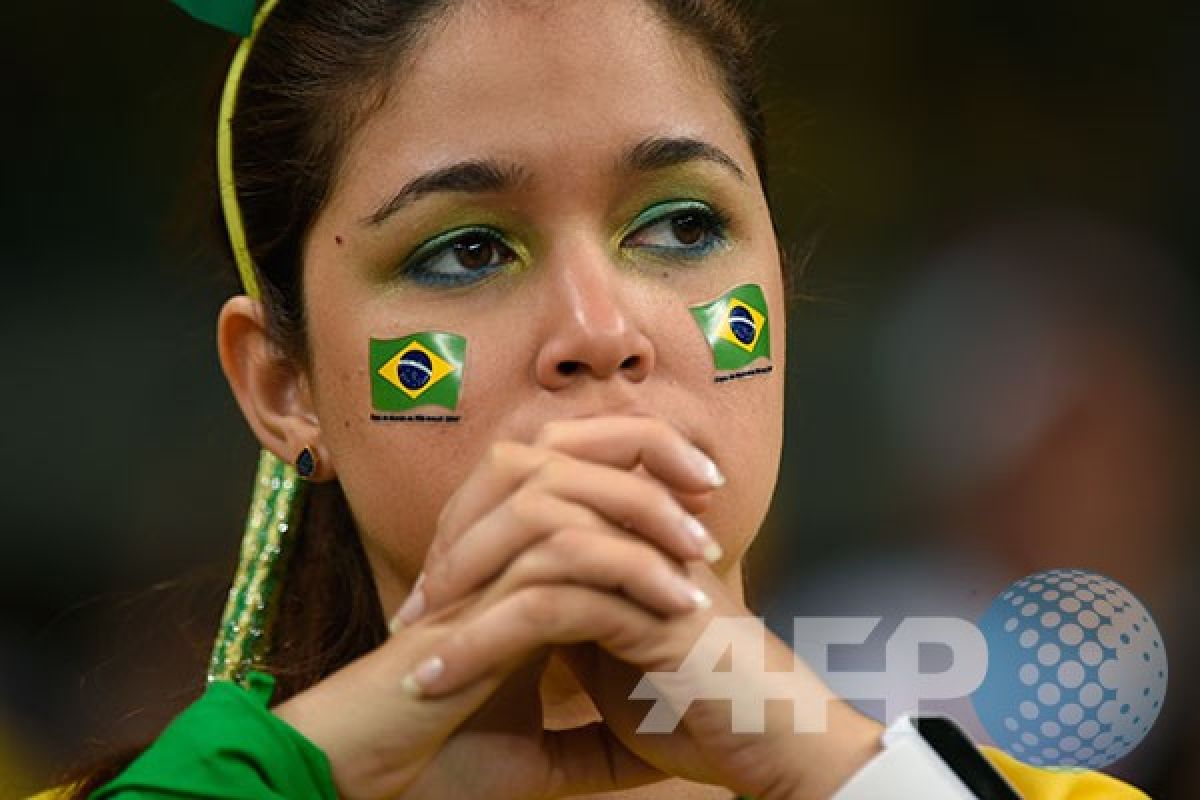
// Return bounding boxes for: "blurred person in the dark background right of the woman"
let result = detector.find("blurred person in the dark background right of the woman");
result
[770,211,1200,796]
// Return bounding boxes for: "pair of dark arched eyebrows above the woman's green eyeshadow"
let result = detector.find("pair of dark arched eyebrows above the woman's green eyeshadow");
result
[364,137,745,227]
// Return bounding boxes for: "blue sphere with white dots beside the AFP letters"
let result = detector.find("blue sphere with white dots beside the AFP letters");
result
[971,570,1166,769]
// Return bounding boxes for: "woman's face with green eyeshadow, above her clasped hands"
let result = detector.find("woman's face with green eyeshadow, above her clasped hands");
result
[305,0,785,610]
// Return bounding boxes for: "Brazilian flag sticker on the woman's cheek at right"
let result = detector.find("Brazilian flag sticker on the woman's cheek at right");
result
[690,283,770,372]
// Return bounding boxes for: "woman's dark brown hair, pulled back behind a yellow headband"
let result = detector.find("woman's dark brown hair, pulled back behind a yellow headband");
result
[65,0,772,798]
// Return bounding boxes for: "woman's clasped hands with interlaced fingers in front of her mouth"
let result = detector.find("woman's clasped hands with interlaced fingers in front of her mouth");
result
[275,416,880,800]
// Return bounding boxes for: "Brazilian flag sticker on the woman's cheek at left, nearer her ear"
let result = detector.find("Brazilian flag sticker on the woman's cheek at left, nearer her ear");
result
[371,332,467,411]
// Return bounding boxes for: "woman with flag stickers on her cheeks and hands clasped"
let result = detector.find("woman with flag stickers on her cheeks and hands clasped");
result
[56,0,1142,800]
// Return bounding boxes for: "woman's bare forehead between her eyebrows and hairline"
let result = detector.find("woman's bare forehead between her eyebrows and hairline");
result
[343,0,754,203]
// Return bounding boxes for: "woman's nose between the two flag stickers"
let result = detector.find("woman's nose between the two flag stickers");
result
[534,251,655,390]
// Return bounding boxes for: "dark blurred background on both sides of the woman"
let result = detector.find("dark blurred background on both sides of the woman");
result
[0,0,1200,798]
